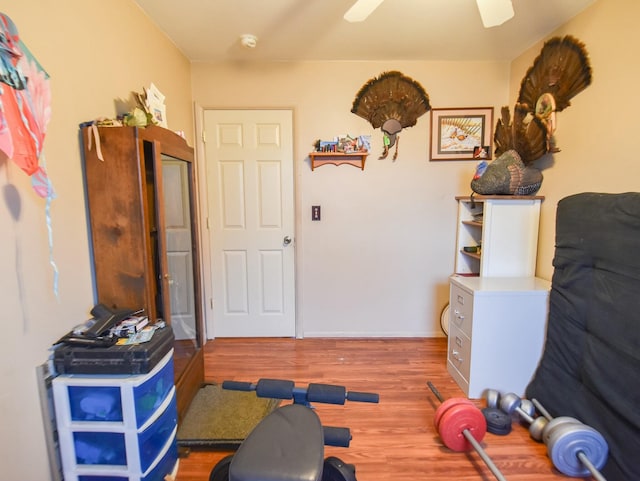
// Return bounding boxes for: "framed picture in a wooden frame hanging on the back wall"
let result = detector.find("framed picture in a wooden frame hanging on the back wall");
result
[431,107,493,160]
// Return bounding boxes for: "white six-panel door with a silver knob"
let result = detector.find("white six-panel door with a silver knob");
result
[204,110,295,337]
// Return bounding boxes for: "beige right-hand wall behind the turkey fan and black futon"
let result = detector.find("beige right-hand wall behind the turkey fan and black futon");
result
[510,0,640,279]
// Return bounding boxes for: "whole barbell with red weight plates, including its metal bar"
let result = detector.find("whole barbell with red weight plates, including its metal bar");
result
[427,381,506,481]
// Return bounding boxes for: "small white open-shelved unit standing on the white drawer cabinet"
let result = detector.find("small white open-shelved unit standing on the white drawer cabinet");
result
[454,195,544,277]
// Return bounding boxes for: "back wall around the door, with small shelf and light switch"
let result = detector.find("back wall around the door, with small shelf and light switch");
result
[192,61,509,336]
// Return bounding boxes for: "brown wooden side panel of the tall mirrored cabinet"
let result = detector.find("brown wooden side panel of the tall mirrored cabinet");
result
[83,128,155,318]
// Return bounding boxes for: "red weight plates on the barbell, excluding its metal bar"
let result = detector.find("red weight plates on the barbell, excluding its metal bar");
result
[438,404,487,451]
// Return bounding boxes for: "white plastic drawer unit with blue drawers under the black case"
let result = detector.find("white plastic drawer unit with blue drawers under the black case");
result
[53,350,178,481]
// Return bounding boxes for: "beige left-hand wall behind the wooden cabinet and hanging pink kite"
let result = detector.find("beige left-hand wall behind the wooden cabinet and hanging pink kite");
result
[0,0,193,480]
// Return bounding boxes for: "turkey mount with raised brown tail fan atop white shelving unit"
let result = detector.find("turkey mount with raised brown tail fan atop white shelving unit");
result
[471,35,591,195]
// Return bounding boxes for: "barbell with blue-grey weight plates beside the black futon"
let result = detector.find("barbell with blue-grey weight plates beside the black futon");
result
[531,399,609,481]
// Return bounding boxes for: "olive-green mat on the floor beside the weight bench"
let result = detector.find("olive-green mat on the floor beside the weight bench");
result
[177,384,280,449]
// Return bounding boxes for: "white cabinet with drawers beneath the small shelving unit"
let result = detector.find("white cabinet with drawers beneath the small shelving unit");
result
[447,275,550,399]
